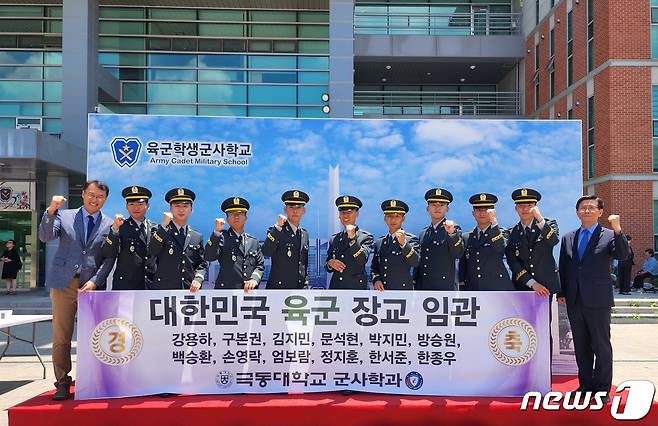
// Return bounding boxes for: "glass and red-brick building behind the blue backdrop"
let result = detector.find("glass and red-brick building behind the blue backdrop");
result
[0,0,644,287]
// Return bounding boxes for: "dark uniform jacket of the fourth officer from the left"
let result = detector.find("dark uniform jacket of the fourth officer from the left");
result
[263,221,308,290]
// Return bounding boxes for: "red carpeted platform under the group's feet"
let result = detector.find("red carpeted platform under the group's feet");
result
[9,377,658,426]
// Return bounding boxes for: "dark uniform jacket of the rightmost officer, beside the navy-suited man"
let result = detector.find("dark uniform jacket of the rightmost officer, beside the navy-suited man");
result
[505,218,560,294]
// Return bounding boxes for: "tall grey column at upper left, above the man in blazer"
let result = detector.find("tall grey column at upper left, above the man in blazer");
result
[62,0,98,149]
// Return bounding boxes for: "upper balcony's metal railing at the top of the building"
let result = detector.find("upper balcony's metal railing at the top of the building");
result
[354,10,521,36]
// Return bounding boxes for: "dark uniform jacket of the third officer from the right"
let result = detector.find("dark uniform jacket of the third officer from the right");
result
[414,219,464,290]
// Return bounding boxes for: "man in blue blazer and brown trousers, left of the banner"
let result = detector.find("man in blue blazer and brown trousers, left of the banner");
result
[39,180,114,401]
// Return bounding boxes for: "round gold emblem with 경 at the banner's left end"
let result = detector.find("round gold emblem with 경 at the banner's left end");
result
[91,318,144,365]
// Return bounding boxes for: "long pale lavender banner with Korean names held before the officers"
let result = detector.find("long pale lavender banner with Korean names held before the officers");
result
[75,290,551,399]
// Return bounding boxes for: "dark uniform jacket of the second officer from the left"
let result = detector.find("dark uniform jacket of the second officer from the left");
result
[147,222,208,290]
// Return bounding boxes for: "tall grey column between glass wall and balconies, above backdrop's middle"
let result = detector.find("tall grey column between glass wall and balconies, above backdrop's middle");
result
[329,0,354,118]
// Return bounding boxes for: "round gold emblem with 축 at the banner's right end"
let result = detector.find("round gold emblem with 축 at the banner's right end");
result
[489,318,537,367]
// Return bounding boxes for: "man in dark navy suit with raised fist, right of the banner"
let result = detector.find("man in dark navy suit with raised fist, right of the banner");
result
[558,195,629,402]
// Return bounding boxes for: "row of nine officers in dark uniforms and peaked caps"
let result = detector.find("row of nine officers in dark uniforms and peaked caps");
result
[103,186,560,296]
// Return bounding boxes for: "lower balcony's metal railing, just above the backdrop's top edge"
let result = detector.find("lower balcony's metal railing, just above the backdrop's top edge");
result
[354,91,521,117]
